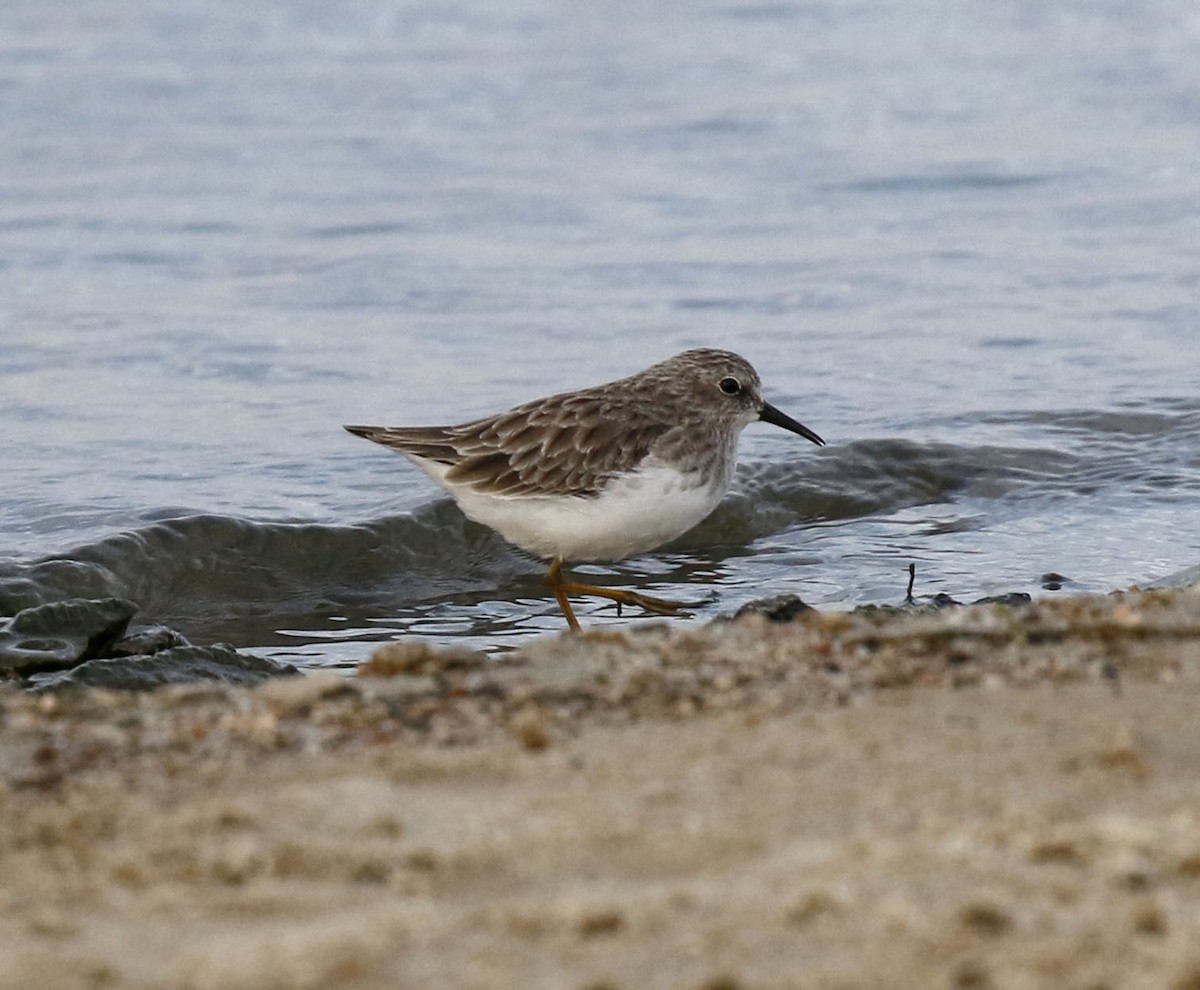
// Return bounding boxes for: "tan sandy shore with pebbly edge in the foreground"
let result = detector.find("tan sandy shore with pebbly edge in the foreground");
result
[0,590,1200,990]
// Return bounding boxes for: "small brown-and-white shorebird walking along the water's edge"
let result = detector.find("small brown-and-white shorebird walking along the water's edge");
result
[346,348,824,630]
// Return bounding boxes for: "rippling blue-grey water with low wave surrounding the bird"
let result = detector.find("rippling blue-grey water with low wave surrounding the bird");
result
[0,0,1200,666]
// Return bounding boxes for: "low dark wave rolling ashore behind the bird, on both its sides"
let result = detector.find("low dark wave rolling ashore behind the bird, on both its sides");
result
[0,432,1190,644]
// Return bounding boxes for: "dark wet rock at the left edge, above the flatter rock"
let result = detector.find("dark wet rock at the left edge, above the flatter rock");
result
[0,598,138,674]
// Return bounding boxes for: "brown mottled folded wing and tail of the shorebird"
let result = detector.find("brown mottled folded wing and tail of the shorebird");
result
[347,391,673,497]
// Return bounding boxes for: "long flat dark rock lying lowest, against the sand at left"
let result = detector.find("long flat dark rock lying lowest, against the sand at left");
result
[30,643,300,691]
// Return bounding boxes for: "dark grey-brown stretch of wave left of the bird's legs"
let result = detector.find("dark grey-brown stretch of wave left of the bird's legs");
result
[0,500,525,631]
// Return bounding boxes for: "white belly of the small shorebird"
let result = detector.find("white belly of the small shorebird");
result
[441,464,728,560]
